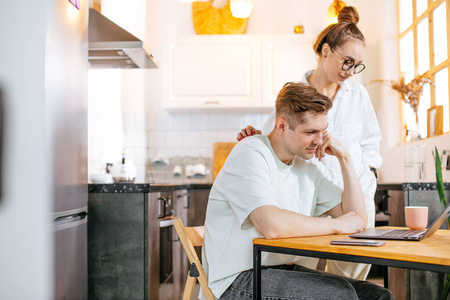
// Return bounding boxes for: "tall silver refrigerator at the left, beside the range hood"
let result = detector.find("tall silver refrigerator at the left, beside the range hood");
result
[45,1,89,300]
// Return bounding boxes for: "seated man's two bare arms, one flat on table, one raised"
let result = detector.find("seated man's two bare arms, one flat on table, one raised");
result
[250,132,367,239]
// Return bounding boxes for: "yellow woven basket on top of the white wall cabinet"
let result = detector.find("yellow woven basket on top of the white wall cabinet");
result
[192,0,248,34]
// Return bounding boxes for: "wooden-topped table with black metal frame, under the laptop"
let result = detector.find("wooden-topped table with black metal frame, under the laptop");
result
[253,227,450,300]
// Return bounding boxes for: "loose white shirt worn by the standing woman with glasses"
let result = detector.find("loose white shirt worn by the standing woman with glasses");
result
[261,70,383,213]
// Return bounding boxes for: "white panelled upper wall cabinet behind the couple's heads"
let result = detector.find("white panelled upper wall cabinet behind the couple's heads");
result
[164,34,316,112]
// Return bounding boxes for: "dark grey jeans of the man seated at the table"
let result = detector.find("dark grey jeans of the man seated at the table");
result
[219,265,394,300]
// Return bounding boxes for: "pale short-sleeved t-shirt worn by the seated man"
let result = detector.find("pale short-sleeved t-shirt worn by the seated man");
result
[202,135,342,298]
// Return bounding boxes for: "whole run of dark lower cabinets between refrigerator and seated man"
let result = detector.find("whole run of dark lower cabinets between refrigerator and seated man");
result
[88,185,210,300]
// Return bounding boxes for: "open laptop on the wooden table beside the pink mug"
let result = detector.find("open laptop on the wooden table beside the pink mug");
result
[350,203,450,241]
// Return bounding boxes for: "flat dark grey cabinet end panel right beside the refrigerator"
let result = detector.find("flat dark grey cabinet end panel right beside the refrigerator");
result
[88,193,155,300]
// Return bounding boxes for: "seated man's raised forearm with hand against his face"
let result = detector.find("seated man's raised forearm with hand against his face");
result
[317,132,367,226]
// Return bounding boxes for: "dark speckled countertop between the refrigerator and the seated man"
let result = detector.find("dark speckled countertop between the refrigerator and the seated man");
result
[88,183,212,193]
